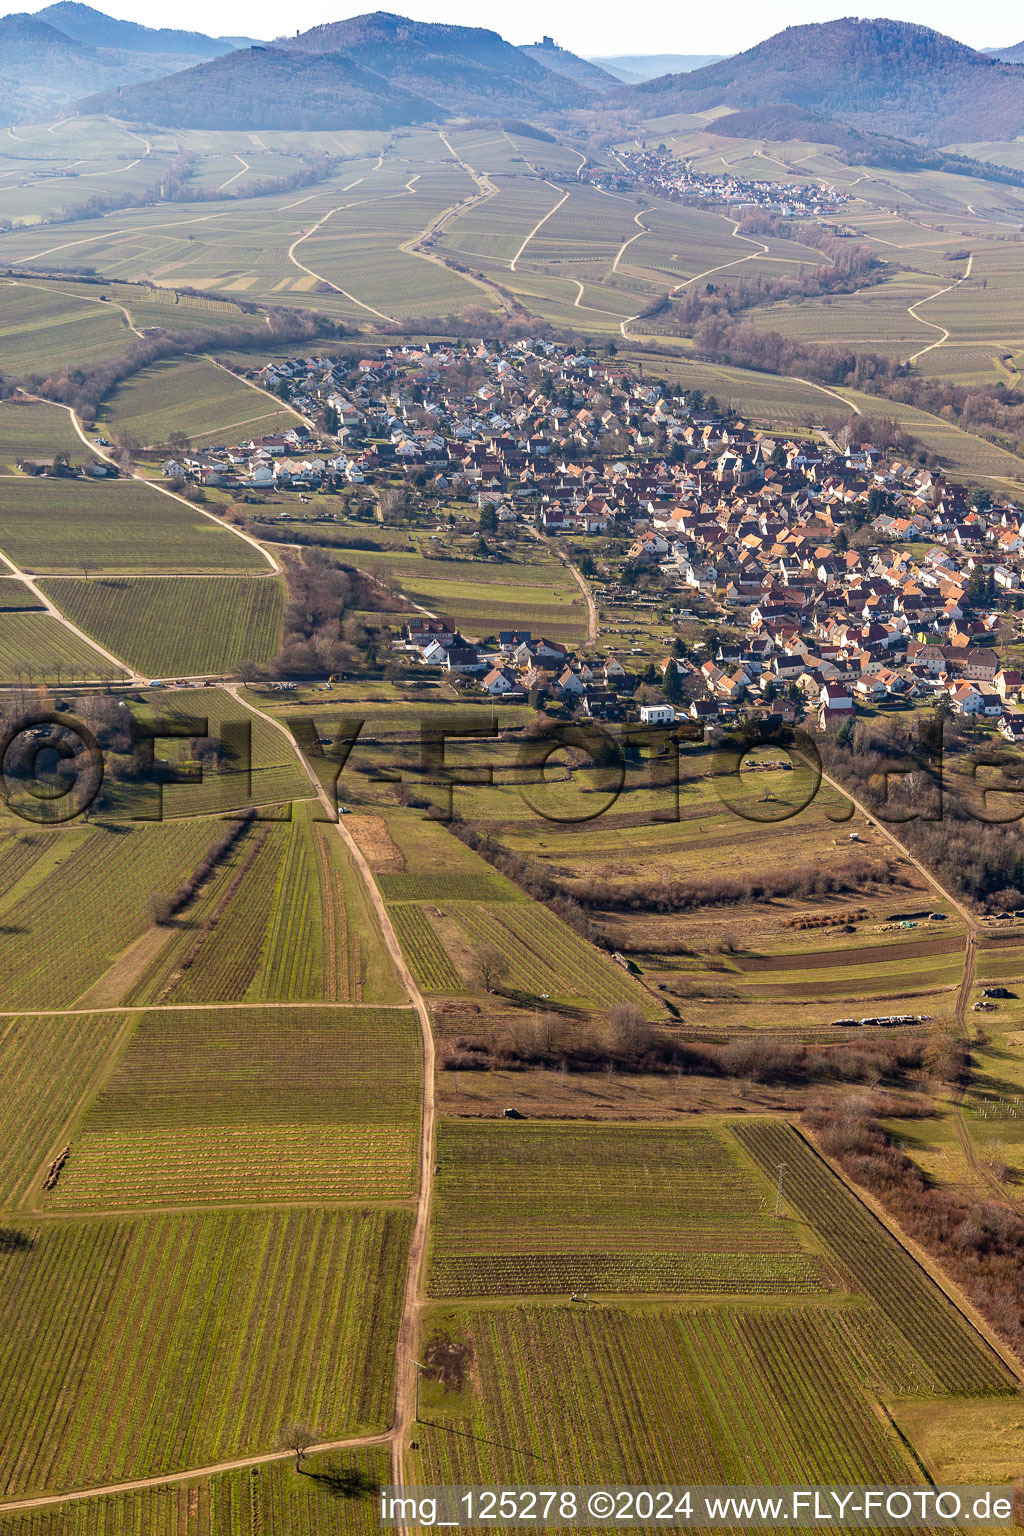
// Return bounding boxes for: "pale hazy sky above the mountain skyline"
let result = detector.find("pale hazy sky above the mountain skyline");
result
[18,0,1024,55]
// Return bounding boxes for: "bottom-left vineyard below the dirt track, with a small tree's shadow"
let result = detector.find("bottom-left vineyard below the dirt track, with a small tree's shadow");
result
[0,1448,390,1536]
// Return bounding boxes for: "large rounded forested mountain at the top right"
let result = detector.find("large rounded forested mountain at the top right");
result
[629,18,1024,144]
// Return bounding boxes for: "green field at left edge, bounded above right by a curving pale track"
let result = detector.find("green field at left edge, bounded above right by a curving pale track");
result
[0,479,266,573]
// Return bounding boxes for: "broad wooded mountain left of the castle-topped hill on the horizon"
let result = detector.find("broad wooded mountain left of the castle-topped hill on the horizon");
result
[80,11,600,129]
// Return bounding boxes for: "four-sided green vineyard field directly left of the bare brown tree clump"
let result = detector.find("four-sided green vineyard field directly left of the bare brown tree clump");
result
[43,576,284,677]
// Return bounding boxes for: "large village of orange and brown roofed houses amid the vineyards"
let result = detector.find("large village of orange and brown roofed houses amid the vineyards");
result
[163,338,1024,740]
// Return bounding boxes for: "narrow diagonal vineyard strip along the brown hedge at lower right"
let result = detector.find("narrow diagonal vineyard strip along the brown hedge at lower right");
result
[734,1120,1013,1395]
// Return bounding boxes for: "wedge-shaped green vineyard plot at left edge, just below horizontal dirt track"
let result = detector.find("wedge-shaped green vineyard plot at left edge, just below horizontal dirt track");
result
[0,1014,124,1209]
